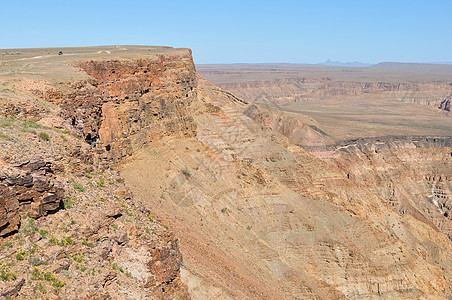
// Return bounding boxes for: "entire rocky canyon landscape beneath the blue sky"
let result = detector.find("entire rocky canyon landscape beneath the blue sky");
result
[0,46,452,299]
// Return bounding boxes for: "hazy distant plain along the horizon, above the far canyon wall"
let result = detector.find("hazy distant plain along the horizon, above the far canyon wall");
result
[196,63,452,84]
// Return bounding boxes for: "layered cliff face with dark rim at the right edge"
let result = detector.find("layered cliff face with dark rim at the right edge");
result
[310,137,452,240]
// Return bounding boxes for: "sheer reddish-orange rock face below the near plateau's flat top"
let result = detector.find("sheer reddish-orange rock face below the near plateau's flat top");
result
[57,51,197,161]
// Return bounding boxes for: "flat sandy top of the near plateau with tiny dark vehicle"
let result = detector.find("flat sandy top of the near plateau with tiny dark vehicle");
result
[0,45,189,83]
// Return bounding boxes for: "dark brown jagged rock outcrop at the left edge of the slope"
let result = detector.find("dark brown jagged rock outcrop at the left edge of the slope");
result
[0,159,64,236]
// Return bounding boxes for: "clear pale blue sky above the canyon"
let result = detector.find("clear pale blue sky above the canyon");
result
[0,0,452,63]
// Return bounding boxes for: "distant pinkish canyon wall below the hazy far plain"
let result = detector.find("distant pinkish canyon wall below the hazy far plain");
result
[219,77,452,114]
